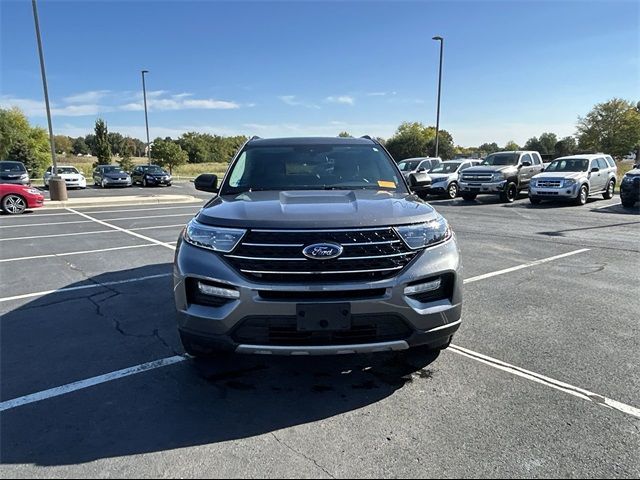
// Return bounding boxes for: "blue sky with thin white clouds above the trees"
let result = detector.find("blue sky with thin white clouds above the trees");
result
[0,0,640,146]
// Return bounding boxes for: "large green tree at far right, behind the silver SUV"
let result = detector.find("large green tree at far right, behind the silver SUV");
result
[577,98,640,158]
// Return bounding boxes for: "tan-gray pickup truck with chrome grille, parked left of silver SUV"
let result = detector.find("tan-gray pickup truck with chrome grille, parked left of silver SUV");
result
[460,151,543,203]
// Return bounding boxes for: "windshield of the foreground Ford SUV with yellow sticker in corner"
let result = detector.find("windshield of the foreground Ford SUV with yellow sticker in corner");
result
[221,144,406,195]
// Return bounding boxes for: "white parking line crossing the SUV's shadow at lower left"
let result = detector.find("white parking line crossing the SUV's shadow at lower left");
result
[0,355,186,412]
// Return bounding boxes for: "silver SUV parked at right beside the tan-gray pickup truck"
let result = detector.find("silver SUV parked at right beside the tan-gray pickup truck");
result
[529,154,618,205]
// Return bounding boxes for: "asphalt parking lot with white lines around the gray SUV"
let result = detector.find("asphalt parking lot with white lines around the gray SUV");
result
[0,190,640,478]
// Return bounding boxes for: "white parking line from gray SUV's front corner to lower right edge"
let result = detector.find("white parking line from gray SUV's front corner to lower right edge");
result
[445,345,640,418]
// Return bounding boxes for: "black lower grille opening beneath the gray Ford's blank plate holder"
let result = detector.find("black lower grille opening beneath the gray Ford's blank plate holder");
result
[231,315,412,346]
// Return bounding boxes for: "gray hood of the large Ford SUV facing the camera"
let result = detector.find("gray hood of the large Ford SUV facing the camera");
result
[196,190,438,228]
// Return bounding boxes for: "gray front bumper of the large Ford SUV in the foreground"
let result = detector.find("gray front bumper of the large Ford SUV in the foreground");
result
[174,237,462,355]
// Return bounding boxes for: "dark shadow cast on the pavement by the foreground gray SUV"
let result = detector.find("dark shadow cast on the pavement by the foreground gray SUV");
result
[0,264,438,465]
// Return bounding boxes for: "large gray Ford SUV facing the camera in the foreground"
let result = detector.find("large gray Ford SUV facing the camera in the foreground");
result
[174,137,462,356]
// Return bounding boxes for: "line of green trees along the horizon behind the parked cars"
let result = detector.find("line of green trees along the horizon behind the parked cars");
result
[0,98,640,176]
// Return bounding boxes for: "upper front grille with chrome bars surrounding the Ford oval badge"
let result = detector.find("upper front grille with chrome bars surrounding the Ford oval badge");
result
[225,227,417,283]
